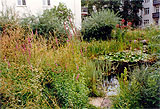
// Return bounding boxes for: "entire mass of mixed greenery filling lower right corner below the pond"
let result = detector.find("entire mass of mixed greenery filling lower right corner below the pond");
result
[113,62,160,108]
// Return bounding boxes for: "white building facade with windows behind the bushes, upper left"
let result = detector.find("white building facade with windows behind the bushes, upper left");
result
[0,0,81,28]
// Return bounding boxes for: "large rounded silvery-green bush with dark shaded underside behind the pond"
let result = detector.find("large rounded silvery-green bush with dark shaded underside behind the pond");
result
[82,10,120,40]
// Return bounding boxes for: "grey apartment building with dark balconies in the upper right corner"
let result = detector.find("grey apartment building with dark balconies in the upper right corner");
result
[141,0,160,27]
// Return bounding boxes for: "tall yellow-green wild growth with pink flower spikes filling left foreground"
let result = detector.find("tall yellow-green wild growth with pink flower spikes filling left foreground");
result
[0,28,92,108]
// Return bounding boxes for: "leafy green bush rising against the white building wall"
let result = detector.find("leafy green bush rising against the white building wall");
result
[21,3,72,38]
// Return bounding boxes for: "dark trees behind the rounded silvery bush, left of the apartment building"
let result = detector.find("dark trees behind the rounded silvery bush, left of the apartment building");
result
[82,0,143,26]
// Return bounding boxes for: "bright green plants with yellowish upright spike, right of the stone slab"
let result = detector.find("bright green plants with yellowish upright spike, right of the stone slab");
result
[113,68,140,109]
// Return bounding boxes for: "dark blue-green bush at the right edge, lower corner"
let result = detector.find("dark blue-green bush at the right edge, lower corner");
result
[132,62,160,108]
